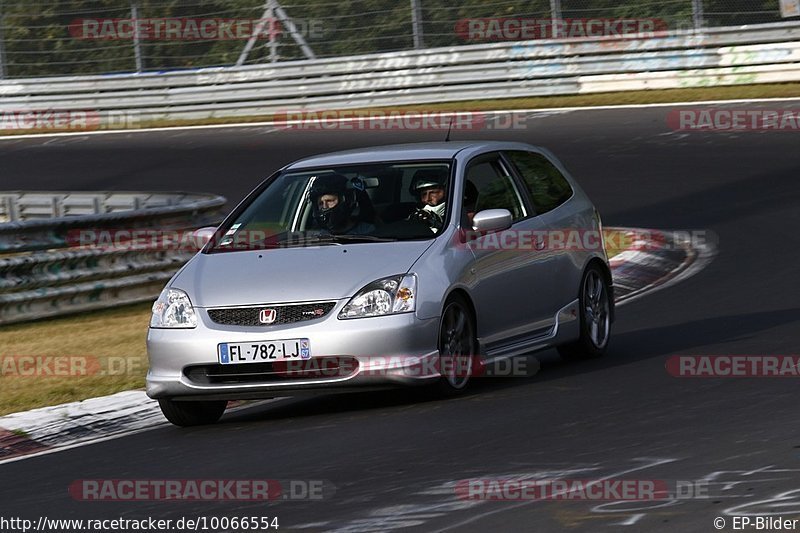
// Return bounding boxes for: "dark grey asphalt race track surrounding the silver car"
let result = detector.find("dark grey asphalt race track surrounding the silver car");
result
[0,103,800,532]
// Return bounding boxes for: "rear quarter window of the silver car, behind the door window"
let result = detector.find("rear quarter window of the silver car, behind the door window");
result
[506,151,572,215]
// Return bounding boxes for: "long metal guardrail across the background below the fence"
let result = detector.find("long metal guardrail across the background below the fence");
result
[0,22,800,127]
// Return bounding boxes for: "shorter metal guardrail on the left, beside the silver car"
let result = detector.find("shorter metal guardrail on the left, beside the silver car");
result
[0,191,226,324]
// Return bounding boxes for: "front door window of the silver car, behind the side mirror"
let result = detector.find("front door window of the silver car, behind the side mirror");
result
[464,156,526,221]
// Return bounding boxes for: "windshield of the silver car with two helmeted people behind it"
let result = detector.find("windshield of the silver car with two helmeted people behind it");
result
[207,161,451,252]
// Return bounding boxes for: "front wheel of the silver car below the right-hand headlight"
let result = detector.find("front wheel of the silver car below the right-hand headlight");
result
[438,295,478,396]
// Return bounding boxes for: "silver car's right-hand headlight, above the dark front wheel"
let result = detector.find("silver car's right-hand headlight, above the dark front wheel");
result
[339,274,417,319]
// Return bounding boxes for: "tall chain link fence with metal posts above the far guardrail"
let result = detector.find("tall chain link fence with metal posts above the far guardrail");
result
[0,0,797,79]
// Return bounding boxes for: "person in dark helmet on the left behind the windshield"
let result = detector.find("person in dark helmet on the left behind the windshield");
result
[308,174,375,235]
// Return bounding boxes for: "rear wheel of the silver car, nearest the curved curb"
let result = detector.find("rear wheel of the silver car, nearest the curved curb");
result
[558,265,613,359]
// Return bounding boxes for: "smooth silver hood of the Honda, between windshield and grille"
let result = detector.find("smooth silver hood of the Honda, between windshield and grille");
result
[171,240,433,307]
